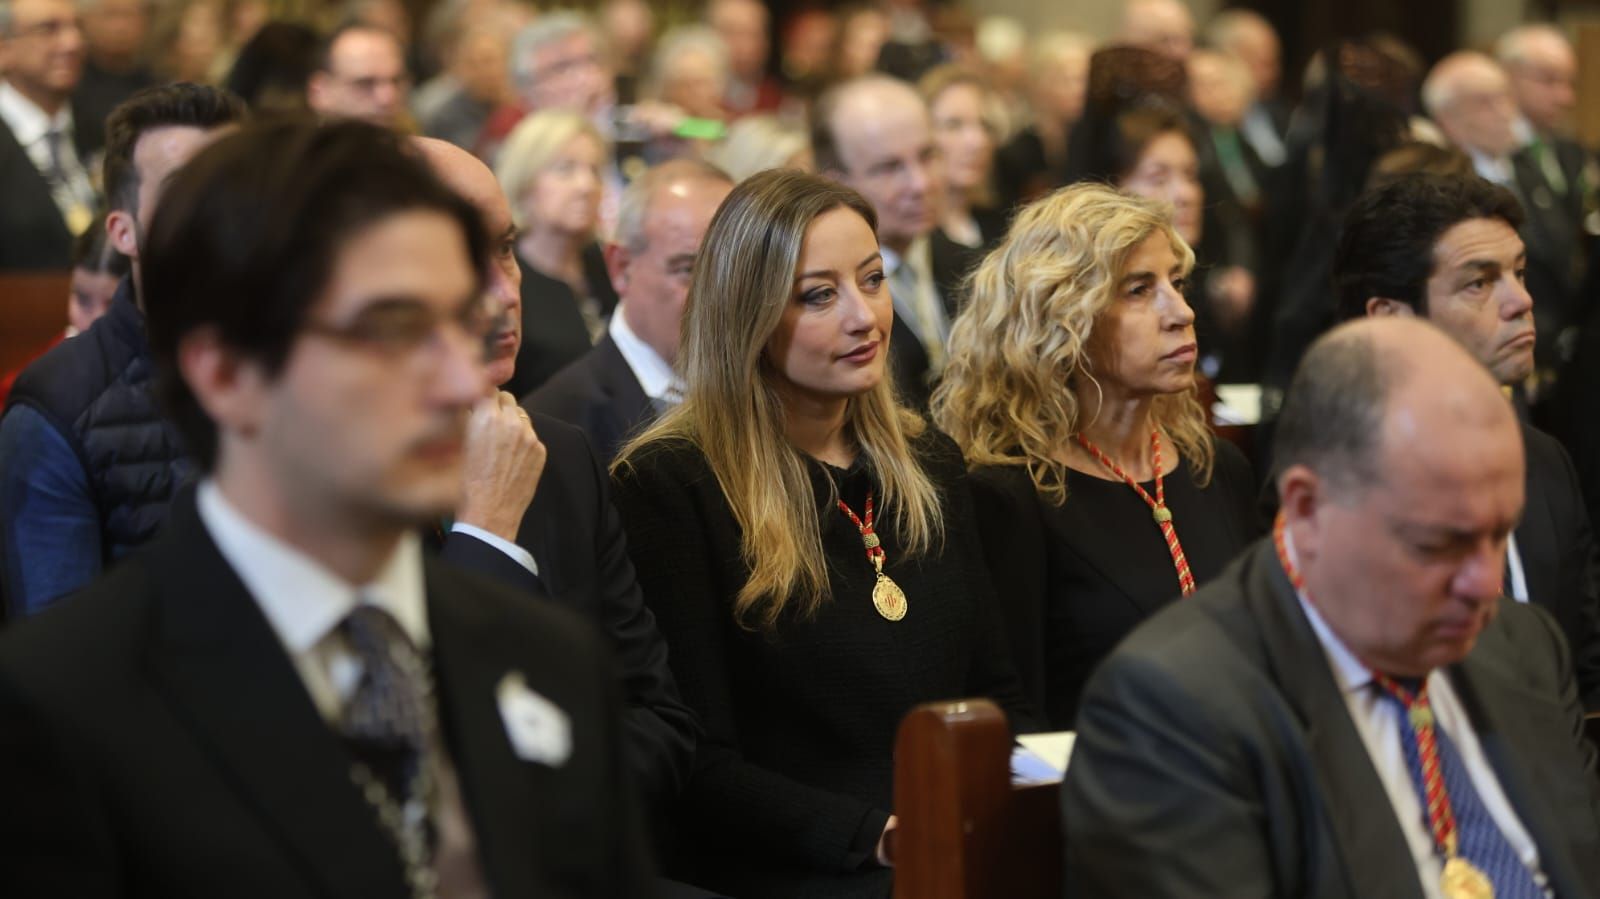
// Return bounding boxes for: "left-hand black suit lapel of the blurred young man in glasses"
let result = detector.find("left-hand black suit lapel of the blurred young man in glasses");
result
[149,494,405,896]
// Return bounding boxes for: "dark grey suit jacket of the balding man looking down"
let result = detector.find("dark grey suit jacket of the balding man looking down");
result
[1062,539,1600,899]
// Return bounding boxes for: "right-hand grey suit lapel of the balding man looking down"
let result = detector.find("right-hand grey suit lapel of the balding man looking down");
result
[1450,630,1594,896]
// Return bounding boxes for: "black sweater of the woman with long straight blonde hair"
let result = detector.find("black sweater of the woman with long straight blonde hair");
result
[604,429,1026,899]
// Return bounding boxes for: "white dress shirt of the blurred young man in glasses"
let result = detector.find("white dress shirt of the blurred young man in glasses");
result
[195,480,488,899]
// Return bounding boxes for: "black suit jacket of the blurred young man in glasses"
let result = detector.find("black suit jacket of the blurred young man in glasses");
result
[0,499,650,899]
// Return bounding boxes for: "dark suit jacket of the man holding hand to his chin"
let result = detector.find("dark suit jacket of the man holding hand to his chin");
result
[443,414,699,808]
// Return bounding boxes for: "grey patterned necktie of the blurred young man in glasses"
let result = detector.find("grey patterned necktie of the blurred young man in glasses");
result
[339,605,437,897]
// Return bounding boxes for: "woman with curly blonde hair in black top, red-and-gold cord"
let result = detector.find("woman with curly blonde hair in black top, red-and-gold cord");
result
[933,184,1261,729]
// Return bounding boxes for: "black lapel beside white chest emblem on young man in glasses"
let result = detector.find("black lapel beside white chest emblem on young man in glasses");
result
[427,560,541,896]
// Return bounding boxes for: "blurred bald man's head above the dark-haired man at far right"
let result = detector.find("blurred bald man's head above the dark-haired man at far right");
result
[1422,50,1517,158]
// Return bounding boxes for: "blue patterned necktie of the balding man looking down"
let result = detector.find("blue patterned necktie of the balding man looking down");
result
[1374,678,1544,899]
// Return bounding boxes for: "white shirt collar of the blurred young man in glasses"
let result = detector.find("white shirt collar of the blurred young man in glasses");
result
[197,478,429,656]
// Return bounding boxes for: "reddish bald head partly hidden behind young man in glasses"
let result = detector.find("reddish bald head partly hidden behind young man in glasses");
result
[411,138,522,386]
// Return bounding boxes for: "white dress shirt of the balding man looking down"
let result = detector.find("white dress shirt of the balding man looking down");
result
[1283,533,1549,899]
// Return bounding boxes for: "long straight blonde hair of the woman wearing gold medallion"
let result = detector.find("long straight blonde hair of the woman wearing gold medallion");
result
[611,170,944,629]
